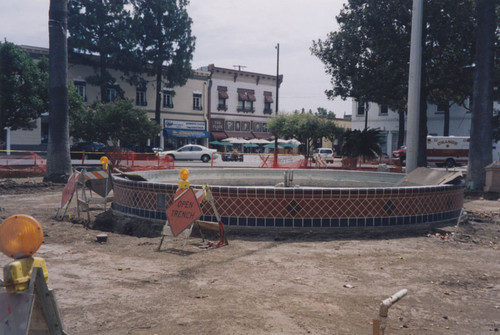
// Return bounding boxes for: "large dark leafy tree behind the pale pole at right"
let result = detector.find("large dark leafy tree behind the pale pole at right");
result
[311,0,474,163]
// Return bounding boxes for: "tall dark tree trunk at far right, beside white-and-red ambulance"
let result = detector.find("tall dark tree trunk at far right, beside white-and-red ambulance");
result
[467,0,496,190]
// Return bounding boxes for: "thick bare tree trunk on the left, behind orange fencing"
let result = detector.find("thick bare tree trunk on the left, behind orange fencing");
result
[45,0,71,182]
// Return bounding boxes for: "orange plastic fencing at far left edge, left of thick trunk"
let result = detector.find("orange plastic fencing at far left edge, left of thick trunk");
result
[0,151,47,178]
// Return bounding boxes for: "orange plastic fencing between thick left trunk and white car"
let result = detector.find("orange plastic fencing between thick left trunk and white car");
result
[106,151,175,172]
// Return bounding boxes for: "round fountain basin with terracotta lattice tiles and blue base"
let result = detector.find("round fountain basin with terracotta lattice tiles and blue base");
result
[112,169,464,229]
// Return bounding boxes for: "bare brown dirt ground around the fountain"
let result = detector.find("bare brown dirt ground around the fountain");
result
[0,180,500,335]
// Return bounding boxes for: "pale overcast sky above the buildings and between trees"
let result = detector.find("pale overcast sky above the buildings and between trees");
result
[0,0,352,118]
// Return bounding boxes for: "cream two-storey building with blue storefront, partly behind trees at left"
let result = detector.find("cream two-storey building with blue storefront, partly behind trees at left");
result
[11,46,210,150]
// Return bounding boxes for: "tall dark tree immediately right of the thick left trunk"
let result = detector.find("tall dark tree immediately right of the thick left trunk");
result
[68,0,135,102]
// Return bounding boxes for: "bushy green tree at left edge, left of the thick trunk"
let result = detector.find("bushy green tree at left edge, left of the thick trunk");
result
[0,41,47,137]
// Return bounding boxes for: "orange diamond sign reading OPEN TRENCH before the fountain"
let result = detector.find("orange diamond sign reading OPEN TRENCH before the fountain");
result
[167,188,201,236]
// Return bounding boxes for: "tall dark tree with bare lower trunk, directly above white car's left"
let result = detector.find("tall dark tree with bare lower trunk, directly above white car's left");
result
[133,0,195,143]
